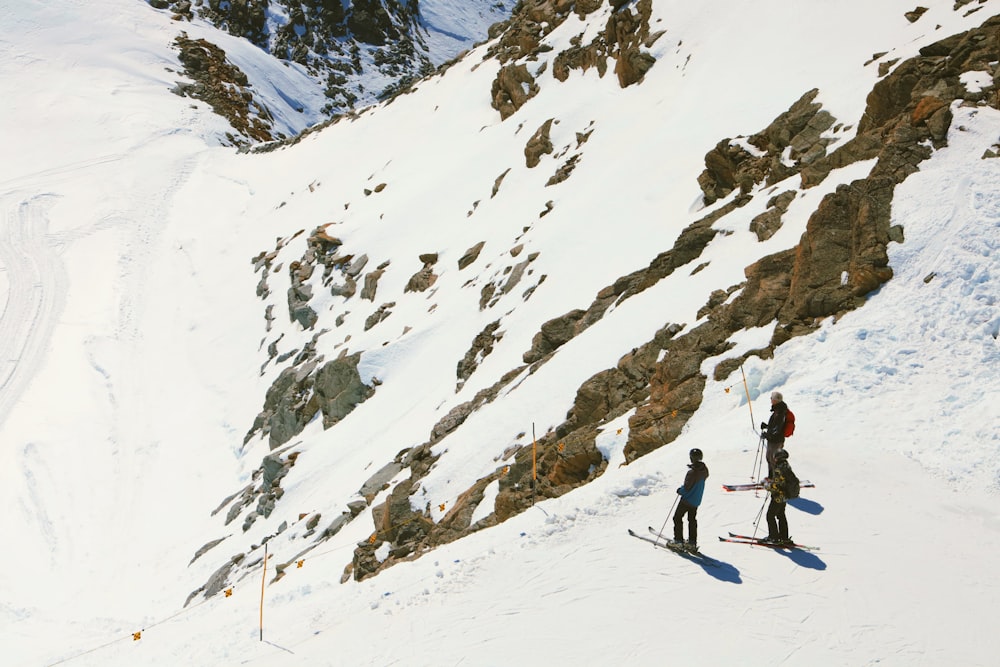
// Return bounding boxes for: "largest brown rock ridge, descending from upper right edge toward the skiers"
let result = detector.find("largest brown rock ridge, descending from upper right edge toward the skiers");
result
[626,17,1000,459]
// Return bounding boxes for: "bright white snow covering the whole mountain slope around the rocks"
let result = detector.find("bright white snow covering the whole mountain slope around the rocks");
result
[0,0,1000,665]
